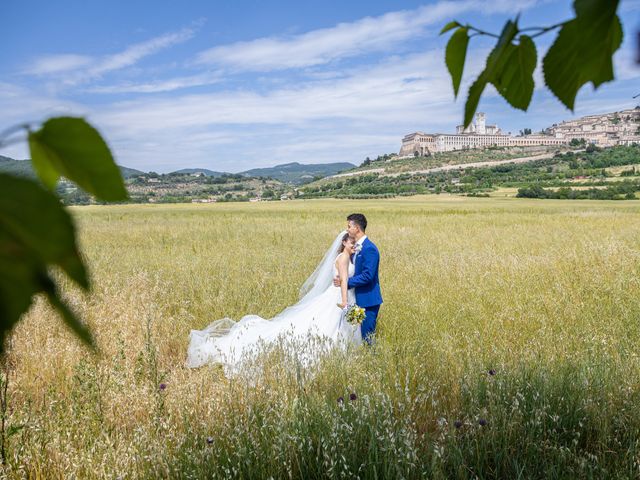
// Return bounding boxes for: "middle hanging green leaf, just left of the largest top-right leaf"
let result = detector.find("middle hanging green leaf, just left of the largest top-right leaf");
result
[490,35,538,110]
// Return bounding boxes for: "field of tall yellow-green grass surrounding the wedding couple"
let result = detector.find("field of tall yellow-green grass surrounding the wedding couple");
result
[4,195,640,479]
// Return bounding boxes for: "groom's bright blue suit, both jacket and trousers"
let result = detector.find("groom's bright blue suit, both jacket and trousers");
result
[348,238,382,344]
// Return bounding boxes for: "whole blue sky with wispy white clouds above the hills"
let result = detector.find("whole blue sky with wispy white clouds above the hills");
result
[0,0,640,172]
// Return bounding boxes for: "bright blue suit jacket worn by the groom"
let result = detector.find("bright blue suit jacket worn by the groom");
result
[349,238,382,307]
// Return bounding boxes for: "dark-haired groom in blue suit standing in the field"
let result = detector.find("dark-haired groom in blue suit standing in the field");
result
[333,213,382,345]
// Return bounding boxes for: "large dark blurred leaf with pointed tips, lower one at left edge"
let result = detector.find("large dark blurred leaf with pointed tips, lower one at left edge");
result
[0,174,92,352]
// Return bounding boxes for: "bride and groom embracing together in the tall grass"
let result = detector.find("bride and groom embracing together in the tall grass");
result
[187,213,382,374]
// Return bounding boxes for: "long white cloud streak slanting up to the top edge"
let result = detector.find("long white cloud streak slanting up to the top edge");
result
[196,0,536,71]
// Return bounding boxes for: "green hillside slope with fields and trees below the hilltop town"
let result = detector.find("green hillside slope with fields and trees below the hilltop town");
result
[299,145,640,200]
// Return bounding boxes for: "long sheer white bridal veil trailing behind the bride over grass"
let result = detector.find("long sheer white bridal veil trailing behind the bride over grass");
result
[187,231,346,373]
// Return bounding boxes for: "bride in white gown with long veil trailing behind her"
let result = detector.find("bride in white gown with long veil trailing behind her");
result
[187,232,362,375]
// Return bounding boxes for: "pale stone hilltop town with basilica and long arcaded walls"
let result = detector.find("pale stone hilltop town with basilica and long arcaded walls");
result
[398,106,640,158]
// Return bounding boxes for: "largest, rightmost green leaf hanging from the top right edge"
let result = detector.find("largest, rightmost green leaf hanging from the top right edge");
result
[542,0,622,110]
